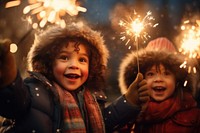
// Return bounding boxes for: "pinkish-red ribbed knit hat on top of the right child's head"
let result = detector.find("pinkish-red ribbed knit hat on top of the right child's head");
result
[146,37,176,52]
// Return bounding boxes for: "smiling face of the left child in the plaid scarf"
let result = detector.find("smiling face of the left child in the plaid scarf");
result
[53,42,89,91]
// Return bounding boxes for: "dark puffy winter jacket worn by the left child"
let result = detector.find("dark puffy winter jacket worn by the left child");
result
[0,73,140,133]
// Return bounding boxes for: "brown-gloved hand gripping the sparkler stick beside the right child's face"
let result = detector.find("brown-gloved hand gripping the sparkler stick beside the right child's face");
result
[125,73,149,106]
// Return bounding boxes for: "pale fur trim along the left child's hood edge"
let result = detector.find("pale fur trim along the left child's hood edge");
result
[28,22,109,70]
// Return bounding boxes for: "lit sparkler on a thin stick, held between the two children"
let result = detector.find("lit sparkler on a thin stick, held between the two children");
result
[119,11,158,72]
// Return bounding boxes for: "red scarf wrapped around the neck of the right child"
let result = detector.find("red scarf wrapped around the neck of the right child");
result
[138,93,196,123]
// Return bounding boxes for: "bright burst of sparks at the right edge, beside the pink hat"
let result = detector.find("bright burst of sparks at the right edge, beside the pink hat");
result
[179,20,200,73]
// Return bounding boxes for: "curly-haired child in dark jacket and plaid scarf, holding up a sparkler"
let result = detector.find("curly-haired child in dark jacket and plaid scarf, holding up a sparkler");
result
[0,22,149,133]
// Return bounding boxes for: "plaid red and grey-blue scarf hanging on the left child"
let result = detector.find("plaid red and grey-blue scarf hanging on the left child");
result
[63,89,105,133]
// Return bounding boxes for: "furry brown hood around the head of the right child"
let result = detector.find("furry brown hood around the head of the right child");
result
[118,48,196,95]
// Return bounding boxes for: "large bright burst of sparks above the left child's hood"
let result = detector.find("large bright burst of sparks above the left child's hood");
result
[5,0,87,29]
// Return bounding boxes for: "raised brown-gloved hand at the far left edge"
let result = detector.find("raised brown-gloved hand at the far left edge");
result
[0,39,17,87]
